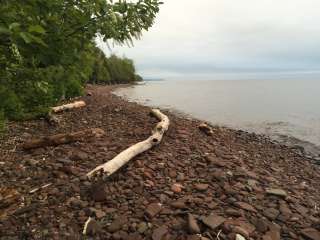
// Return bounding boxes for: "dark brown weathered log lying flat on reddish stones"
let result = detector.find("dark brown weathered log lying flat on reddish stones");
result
[22,128,105,149]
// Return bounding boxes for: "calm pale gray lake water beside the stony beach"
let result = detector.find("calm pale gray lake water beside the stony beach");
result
[116,80,320,156]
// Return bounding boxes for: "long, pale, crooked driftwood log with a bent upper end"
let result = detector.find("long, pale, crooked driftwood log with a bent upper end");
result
[87,109,170,178]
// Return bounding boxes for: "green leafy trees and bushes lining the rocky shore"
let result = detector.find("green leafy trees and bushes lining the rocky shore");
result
[0,0,161,122]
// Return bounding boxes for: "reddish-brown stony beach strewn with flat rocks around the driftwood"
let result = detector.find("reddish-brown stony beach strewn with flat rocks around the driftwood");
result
[0,86,320,240]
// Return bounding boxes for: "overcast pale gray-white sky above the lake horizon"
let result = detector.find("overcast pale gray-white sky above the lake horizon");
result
[97,0,320,77]
